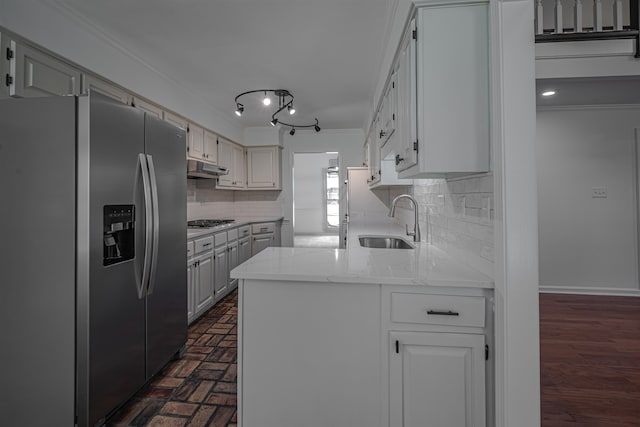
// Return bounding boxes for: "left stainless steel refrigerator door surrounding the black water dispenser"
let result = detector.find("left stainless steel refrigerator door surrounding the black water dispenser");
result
[77,94,147,426]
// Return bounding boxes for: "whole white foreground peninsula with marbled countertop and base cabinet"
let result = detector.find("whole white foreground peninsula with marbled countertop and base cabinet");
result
[231,220,493,427]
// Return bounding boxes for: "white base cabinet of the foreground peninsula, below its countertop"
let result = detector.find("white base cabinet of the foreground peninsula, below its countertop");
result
[238,279,493,427]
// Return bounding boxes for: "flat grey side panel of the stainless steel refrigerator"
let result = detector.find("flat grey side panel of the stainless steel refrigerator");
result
[0,97,76,427]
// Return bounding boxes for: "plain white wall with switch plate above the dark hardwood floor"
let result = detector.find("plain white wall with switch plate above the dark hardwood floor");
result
[536,108,640,293]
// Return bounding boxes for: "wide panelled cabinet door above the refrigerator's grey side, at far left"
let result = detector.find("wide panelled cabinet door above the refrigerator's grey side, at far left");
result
[9,41,80,98]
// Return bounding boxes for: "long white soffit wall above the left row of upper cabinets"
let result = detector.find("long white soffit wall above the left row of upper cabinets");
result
[0,0,243,143]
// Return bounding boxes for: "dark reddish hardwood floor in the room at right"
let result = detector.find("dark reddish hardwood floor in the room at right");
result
[540,294,640,427]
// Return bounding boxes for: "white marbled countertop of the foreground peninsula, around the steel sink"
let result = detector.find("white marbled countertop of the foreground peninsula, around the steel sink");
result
[231,219,493,288]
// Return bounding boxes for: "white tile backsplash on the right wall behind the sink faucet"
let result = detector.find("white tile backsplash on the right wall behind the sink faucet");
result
[398,174,495,277]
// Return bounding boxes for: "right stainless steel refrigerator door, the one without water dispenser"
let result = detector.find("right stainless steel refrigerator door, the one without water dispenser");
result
[145,115,187,378]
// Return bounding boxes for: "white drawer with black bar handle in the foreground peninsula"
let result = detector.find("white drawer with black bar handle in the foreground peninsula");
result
[391,293,485,328]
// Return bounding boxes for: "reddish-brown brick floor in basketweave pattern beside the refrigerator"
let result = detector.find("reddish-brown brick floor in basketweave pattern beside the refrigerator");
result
[107,291,238,427]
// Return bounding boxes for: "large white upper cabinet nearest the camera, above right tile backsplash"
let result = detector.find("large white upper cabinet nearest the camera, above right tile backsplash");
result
[399,1,490,178]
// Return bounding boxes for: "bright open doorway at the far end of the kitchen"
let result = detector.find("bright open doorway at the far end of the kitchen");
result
[293,152,340,248]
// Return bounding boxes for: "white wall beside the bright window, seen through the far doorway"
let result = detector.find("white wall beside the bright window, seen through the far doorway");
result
[293,153,338,234]
